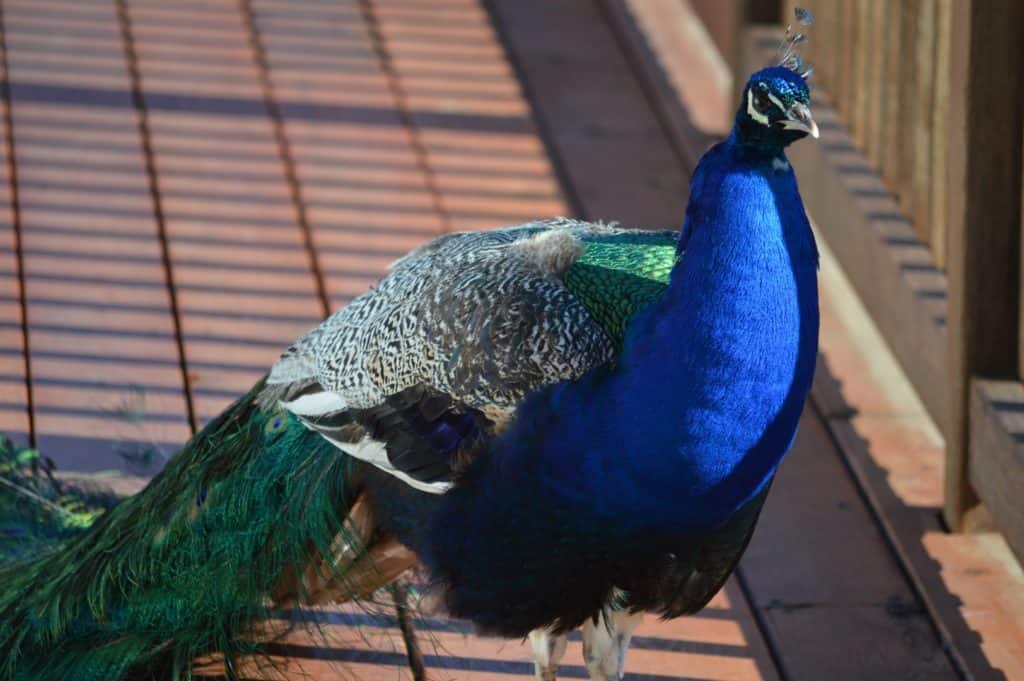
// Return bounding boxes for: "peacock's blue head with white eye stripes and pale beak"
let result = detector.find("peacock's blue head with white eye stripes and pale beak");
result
[733,66,818,154]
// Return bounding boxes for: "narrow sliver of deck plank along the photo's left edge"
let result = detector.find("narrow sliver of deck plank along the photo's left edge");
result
[0,27,32,444]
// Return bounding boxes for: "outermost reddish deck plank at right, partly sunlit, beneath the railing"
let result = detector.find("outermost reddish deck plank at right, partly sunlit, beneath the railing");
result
[812,227,1024,681]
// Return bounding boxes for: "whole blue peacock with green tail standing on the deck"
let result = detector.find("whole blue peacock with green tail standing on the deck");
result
[0,10,818,681]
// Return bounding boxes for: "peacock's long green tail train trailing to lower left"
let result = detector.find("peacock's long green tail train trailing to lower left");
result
[0,381,370,681]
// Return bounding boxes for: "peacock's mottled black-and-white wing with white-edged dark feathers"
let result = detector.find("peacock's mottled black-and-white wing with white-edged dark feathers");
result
[262,219,622,494]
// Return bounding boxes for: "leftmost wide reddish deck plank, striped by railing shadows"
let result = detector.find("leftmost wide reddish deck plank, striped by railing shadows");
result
[4,0,189,475]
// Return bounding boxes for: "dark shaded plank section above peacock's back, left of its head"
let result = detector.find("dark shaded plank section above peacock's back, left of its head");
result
[489,0,689,227]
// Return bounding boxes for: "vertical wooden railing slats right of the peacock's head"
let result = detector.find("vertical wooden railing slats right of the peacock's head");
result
[802,0,953,268]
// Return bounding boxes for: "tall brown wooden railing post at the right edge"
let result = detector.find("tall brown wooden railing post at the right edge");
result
[944,0,1024,529]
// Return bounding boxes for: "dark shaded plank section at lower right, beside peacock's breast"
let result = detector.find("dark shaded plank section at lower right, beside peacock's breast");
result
[740,412,958,681]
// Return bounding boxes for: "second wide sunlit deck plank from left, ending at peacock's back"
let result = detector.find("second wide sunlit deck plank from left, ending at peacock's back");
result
[127,0,324,423]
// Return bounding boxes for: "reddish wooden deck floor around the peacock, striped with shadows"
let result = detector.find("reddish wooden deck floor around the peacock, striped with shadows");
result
[0,0,1024,681]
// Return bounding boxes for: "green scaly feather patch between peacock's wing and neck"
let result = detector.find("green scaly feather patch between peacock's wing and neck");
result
[563,231,679,350]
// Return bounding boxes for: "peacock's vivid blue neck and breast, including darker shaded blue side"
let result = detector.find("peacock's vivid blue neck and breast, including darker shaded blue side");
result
[532,135,818,527]
